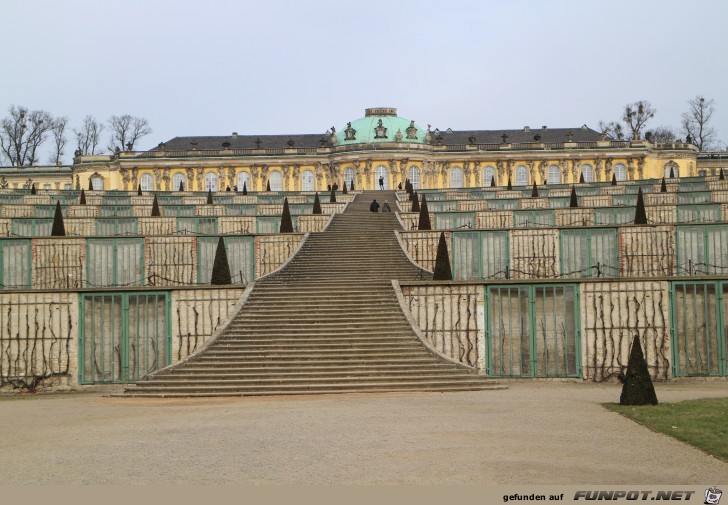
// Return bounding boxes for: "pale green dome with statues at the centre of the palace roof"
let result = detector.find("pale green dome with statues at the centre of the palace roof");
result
[336,107,427,145]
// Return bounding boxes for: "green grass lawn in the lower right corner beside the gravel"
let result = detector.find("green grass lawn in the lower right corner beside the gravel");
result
[604,398,728,462]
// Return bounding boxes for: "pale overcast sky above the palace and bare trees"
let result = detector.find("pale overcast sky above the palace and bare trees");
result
[0,0,728,161]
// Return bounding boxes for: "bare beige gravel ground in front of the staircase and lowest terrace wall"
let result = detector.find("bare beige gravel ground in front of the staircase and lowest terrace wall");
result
[0,381,728,485]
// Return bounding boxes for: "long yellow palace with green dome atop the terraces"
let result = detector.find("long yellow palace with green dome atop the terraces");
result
[64,108,699,192]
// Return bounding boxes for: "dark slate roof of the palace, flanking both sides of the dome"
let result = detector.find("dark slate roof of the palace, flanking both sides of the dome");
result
[152,126,599,151]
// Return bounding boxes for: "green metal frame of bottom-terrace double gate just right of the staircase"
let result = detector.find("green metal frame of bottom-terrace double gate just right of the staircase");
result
[484,283,582,377]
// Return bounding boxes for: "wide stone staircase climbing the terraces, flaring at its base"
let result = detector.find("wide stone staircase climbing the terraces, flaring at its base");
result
[126,191,503,397]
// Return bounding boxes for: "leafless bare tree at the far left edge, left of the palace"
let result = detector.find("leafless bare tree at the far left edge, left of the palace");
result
[0,105,53,167]
